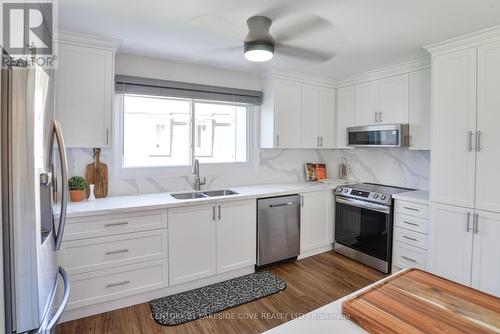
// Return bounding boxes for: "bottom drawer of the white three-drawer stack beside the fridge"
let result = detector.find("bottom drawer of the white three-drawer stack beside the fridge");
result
[66,259,168,310]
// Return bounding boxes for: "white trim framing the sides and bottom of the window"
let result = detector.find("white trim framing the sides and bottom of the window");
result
[113,93,259,177]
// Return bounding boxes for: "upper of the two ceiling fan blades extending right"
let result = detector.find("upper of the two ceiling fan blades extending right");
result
[273,14,335,43]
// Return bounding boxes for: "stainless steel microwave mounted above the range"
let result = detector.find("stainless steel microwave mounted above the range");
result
[347,124,409,147]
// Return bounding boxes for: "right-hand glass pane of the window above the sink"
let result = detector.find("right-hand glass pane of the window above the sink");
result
[194,102,247,163]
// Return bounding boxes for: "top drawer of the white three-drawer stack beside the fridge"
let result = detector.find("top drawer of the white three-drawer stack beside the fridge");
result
[64,210,167,240]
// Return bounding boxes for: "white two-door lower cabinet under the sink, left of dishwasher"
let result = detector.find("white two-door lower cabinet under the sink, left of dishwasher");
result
[168,200,256,285]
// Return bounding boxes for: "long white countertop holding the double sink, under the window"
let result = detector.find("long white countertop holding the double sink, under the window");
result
[62,179,345,217]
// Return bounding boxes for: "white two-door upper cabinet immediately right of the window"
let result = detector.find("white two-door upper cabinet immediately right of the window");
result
[260,77,335,148]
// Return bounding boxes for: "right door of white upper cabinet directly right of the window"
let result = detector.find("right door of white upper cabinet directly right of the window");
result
[300,84,320,148]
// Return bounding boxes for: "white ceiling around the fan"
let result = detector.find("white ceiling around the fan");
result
[59,0,500,78]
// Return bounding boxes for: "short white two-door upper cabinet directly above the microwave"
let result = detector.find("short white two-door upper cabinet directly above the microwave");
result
[356,74,409,125]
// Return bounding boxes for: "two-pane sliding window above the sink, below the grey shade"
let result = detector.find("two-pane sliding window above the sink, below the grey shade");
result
[122,94,249,168]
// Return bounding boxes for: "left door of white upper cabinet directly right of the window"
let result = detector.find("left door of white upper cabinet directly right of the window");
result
[274,79,302,148]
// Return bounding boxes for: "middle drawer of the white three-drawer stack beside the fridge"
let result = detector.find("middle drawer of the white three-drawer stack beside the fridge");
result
[59,229,168,274]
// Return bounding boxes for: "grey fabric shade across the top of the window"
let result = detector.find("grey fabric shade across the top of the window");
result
[115,75,262,105]
